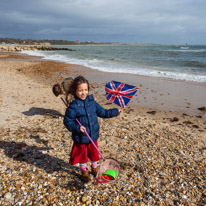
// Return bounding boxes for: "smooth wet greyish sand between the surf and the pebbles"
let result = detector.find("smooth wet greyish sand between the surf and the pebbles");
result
[83,70,206,119]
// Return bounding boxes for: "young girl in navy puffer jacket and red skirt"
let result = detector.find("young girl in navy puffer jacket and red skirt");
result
[64,76,121,183]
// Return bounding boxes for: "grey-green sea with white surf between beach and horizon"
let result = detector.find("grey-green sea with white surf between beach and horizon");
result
[22,44,206,82]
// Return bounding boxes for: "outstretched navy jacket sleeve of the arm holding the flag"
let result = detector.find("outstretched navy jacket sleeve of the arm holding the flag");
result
[95,102,119,118]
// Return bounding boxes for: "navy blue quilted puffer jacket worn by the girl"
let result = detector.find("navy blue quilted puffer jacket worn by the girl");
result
[64,95,119,144]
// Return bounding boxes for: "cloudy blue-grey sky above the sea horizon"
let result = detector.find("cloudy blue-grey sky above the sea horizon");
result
[0,0,206,45]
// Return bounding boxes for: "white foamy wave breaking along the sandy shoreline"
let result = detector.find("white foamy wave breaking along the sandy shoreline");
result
[21,51,206,82]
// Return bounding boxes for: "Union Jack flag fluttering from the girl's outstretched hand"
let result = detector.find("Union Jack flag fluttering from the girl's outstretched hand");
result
[105,81,140,108]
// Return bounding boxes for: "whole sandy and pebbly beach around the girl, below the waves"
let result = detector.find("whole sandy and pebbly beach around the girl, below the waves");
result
[0,51,206,206]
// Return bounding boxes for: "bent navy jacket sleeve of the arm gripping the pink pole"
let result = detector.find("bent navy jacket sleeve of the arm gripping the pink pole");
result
[63,107,80,133]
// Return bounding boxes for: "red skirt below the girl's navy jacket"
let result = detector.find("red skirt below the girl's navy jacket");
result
[69,141,99,165]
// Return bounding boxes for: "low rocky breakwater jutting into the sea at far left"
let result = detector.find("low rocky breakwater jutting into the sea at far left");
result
[0,45,74,52]
